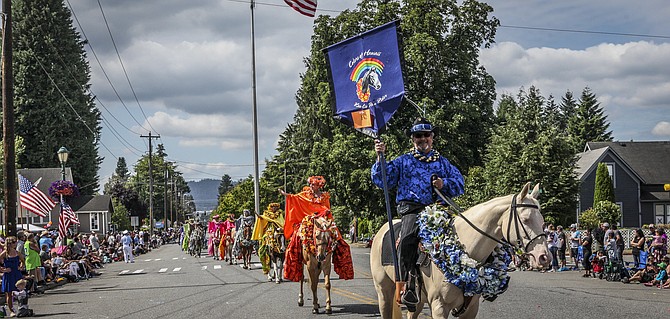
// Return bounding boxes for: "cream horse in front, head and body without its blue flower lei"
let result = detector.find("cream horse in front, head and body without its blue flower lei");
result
[370,183,551,318]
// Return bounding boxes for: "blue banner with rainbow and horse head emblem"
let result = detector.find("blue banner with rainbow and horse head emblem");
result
[324,21,405,138]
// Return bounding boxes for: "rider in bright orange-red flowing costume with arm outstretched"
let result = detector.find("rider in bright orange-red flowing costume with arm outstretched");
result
[279,176,354,282]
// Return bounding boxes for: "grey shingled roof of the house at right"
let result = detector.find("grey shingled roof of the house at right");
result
[585,141,670,184]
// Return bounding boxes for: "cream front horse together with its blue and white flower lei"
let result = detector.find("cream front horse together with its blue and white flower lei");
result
[370,183,551,318]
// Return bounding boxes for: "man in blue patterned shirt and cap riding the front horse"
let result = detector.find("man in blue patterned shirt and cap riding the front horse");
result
[372,118,464,308]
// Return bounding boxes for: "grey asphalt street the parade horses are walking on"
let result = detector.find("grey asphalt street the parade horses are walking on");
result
[30,244,670,319]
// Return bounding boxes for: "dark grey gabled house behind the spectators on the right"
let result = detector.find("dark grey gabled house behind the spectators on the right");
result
[577,141,670,227]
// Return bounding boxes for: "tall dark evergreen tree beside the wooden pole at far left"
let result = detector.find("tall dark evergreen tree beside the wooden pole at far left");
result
[12,0,102,194]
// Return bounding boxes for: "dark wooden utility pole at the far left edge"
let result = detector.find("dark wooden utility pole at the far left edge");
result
[1,0,16,236]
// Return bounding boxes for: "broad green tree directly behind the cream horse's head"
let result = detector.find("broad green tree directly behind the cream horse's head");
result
[484,87,578,224]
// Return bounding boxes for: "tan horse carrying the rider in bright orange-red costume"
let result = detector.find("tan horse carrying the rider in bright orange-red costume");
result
[298,217,335,314]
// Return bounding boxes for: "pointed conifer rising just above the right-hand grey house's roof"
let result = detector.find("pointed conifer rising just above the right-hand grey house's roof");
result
[568,88,612,151]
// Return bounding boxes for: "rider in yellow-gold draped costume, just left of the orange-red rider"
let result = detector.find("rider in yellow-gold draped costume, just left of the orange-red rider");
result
[251,203,285,275]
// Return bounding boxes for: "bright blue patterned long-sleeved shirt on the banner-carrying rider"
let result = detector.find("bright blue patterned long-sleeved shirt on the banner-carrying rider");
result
[372,151,465,205]
